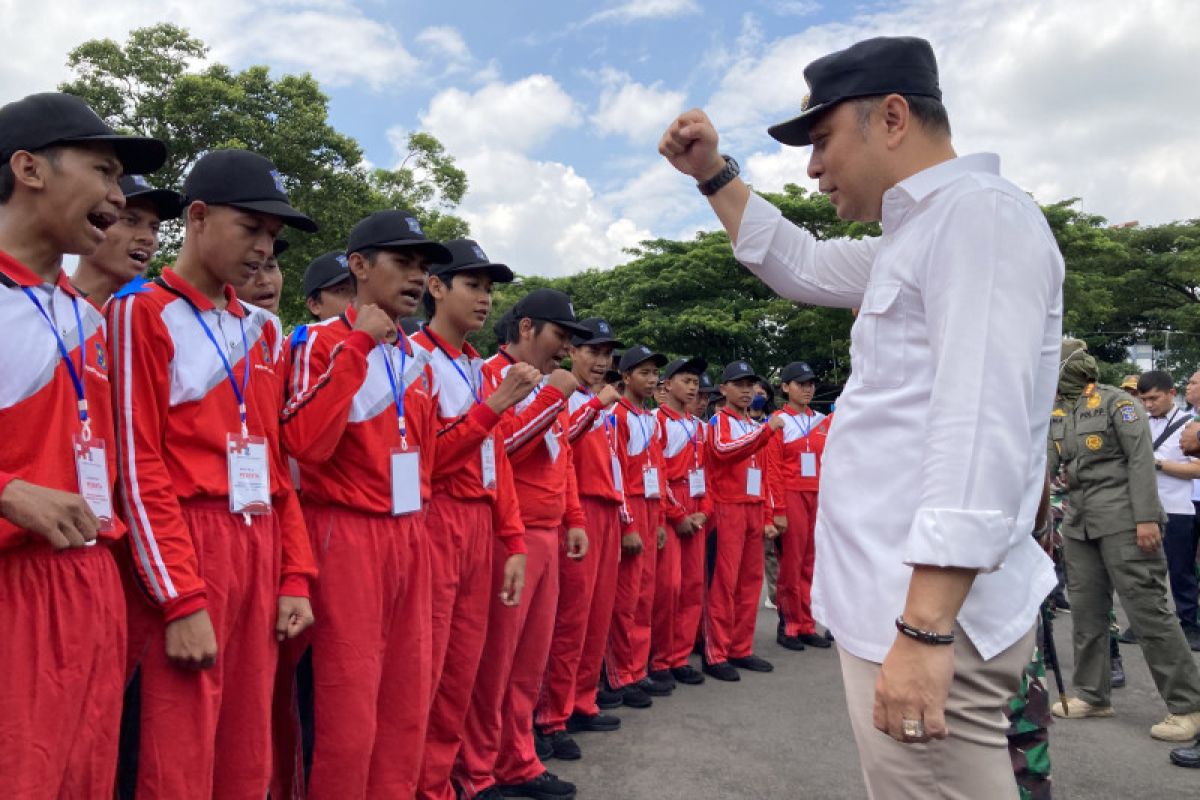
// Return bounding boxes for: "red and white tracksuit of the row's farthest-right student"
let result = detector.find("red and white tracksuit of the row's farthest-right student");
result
[767,405,833,636]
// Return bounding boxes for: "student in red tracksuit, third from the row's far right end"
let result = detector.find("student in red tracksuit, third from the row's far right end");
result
[650,359,713,684]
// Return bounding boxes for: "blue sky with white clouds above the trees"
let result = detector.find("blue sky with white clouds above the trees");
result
[0,0,1200,275]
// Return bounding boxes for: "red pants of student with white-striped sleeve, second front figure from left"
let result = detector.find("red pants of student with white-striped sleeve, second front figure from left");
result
[138,498,280,800]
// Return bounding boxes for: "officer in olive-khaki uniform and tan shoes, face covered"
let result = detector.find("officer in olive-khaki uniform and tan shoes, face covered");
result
[1048,339,1200,741]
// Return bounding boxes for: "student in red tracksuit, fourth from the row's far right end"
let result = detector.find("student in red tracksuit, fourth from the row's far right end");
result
[605,344,672,709]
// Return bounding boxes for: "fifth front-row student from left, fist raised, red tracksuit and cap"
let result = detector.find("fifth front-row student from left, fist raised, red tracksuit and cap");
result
[412,239,541,800]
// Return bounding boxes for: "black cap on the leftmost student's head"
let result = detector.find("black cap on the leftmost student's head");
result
[0,91,167,175]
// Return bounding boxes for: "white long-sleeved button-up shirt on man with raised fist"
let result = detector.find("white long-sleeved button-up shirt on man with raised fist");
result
[734,154,1063,662]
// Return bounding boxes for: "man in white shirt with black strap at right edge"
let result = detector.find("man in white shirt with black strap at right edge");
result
[1134,369,1200,651]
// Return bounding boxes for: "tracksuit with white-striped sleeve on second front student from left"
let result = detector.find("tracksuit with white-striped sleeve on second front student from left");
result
[108,269,317,798]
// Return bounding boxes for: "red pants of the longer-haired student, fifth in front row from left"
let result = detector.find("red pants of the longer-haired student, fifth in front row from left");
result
[455,528,565,798]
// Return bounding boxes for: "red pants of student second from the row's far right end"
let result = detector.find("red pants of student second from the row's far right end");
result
[704,503,764,664]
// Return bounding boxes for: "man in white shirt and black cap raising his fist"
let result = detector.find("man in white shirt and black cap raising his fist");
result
[659,38,1063,798]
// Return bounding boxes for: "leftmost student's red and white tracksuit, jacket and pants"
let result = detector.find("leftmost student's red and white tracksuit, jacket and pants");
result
[0,251,125,798]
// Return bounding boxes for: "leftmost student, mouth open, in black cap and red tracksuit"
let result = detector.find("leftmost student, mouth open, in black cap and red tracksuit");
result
[0,94,166,798]
